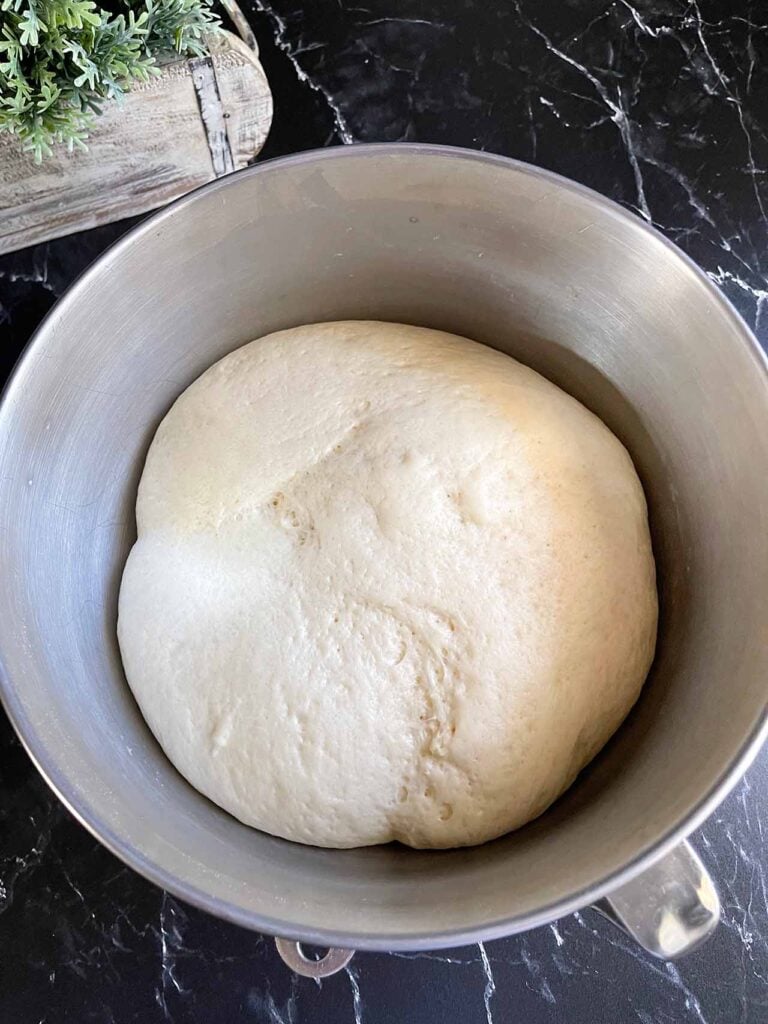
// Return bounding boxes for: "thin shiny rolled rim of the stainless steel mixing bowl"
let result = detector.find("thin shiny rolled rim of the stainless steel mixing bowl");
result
[0,142,768,951]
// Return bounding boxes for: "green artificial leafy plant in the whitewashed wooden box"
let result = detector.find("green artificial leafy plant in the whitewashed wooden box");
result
[0,0,218,162]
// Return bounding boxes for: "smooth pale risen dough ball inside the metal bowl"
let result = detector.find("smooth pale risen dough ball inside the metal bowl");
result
[119,322,656,847]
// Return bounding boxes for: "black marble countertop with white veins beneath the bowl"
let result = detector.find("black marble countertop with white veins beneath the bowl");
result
[0,0,768,1024]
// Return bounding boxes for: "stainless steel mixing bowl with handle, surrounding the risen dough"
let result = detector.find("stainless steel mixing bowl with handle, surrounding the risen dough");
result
[0,145,768,970]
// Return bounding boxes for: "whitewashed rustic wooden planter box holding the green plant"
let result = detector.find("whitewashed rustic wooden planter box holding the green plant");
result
[0,24,272,253]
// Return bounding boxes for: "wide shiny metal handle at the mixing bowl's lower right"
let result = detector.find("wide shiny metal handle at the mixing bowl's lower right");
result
[594,843,720,959]
